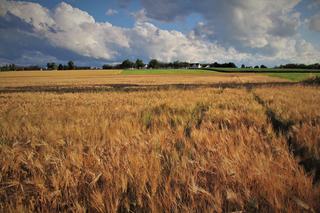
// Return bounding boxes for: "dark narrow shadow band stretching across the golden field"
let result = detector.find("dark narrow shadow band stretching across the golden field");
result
[0,82,307,93]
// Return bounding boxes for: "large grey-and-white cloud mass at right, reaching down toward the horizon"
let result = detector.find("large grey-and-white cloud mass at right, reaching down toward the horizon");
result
[128,0,320,63]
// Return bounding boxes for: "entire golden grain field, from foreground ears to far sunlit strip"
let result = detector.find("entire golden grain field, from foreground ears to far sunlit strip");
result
[0,70,320,212]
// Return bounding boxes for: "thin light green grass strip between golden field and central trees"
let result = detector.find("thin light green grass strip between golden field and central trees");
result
[121,69,216,75]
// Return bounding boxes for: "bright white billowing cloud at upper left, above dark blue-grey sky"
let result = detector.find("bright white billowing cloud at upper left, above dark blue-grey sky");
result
[2,1,129,59]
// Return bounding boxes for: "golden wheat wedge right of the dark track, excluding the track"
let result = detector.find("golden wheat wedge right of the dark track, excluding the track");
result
[257,87,320,159]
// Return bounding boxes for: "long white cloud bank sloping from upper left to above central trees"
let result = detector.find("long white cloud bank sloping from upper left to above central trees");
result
[0,2,249,61]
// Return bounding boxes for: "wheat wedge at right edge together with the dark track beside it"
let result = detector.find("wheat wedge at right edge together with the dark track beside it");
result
[257,88,320,181]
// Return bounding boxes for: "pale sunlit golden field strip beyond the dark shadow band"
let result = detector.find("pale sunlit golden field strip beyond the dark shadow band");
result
[0,70,287,88]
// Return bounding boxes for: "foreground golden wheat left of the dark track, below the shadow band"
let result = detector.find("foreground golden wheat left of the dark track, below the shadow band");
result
[0,88,320,212]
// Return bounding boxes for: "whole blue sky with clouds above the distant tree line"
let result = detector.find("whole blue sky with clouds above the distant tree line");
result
[0,0,320,66]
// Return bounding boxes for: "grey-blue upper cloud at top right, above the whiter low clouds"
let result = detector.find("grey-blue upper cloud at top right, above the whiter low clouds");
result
[141,0,300,48]
